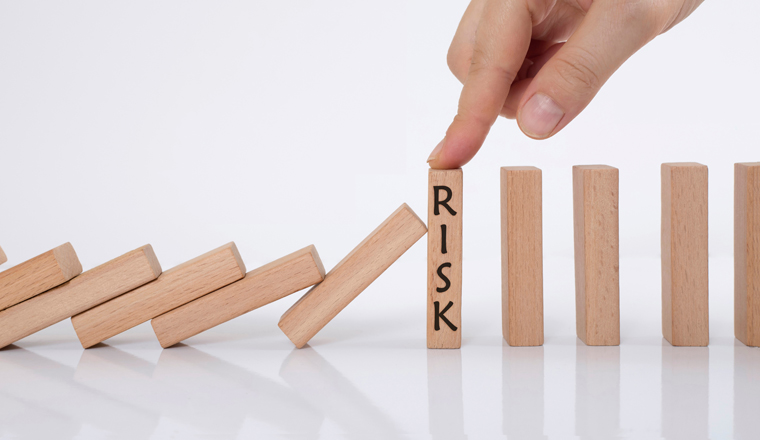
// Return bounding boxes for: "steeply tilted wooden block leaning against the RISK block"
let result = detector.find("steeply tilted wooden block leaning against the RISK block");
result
[279,203,427,348]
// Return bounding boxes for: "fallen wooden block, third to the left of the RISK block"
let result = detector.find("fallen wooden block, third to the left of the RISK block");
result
[71,243,245,348]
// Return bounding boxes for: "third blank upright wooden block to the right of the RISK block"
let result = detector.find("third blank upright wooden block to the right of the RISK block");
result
[662,163,710,346]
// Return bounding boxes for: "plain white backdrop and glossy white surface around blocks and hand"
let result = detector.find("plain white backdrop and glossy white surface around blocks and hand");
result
[0,0,760,438]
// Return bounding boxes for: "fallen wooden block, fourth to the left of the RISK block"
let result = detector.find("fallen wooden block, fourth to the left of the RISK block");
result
[0,245,161,347]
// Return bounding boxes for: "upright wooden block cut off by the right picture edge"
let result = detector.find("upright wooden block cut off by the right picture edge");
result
[734,162,760,347]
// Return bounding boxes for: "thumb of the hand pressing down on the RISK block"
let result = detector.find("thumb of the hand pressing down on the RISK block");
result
[517,1,661,139]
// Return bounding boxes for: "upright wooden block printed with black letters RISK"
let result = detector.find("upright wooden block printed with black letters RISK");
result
[427,168,462,348]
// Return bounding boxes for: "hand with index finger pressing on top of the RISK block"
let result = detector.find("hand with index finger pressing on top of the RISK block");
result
[428,0,703,168]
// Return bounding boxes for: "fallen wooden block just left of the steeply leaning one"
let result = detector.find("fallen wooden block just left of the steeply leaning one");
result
[151,246,325,348]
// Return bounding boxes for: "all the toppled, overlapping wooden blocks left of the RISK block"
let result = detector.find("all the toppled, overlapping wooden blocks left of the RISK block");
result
[0,204,427,348]
